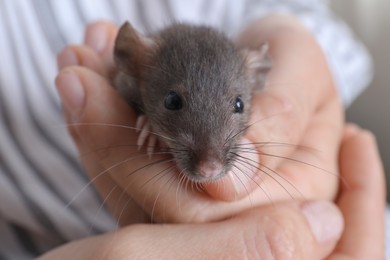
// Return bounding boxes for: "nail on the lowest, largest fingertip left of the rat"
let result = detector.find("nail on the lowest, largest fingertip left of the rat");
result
[56,70,85,122]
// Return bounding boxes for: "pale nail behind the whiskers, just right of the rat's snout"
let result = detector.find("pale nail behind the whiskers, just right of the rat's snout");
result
[228,138,259,194]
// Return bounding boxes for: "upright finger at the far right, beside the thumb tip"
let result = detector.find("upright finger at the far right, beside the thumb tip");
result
[334,126,385,259]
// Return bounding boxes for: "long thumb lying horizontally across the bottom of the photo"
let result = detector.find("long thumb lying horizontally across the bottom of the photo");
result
[99,200,342,259]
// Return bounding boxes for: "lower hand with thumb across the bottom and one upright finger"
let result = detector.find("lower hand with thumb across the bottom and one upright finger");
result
[41,126,385,260]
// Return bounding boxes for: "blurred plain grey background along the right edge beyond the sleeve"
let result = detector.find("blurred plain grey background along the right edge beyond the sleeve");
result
[330,0,390,201]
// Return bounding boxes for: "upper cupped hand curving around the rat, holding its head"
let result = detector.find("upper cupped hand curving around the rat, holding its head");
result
[57,16,342,222]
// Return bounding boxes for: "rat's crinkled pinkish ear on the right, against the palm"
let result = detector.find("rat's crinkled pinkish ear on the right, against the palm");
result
[242,43,272,87]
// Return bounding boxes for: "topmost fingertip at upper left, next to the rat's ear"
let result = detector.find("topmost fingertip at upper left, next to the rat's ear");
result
[84,21,118,72]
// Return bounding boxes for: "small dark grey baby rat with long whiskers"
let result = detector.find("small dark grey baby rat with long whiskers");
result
[114,22,271,183]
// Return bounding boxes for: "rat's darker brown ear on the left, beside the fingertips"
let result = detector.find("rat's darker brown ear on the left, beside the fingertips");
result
[114,22,156,78]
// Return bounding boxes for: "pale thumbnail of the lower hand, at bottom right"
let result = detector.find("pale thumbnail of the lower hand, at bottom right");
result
[301,201,344,244]
